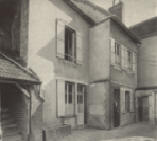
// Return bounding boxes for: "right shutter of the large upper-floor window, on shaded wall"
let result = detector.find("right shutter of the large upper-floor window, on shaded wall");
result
[76,32,83,64]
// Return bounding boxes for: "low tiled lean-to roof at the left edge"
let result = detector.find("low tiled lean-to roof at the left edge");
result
[0,53,40,83]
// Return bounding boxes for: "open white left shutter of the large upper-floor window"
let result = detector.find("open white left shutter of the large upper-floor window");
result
[56,19,66,59]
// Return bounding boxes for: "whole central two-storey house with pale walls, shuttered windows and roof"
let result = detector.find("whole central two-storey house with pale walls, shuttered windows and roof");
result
[24,0,140,139]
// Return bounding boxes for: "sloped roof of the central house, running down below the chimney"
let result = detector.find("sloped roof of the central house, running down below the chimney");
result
[64,0,140,43]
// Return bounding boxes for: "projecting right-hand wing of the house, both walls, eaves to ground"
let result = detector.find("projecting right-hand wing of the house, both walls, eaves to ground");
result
[88,17,139,129]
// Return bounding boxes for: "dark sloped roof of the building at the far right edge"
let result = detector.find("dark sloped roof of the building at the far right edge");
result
[130,17,157,38]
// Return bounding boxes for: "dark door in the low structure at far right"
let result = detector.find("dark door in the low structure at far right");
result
[138,96,149,121]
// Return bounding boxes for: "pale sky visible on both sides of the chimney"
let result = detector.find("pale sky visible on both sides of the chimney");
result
[90,0,157,26]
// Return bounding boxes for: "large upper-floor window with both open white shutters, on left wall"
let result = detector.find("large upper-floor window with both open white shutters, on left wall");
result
[56,19,83,64]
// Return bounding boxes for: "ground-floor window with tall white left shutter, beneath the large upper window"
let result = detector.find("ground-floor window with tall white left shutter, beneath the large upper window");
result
[56,80,86,117]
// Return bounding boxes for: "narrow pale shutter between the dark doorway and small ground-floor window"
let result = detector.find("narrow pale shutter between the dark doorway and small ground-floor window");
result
[120,88,125,113]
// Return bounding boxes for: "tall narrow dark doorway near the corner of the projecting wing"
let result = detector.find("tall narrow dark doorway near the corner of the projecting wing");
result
[113,89,120,127]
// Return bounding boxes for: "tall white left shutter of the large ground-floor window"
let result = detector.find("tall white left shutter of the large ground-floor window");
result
[57,80,65,117]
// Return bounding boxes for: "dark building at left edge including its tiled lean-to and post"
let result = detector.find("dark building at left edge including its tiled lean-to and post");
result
[0,0,43,141]
